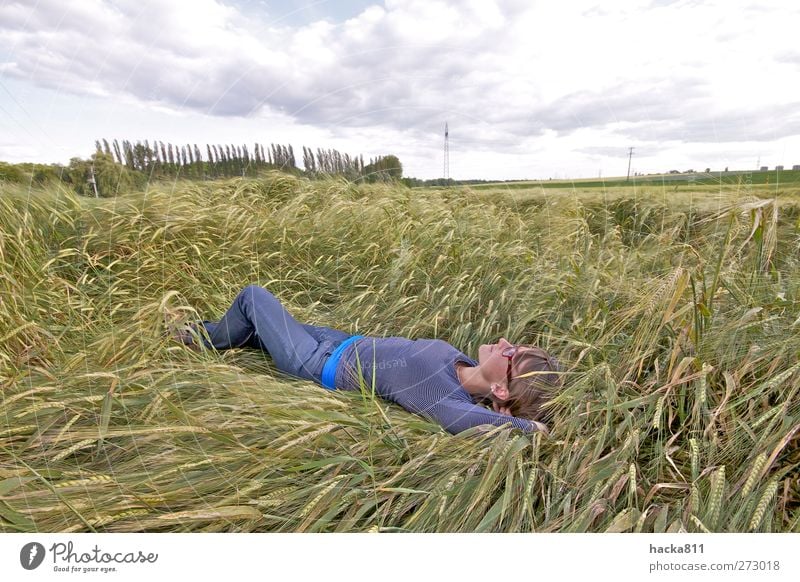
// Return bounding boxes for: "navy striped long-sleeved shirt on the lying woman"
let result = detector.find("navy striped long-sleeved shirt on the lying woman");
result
[336,337,536,434]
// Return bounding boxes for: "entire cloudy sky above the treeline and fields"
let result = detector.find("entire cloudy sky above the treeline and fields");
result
[0,0,800,180]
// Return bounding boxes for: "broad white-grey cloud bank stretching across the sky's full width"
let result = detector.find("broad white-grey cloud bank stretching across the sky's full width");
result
[0,0,800,172]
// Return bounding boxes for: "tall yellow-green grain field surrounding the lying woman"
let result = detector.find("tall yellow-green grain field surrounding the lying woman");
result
[0,174,800,532]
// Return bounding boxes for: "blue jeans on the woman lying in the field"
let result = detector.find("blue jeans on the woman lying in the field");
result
[195,285,351,384]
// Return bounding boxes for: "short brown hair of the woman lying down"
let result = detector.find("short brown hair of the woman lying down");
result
[504,346,562,423]
